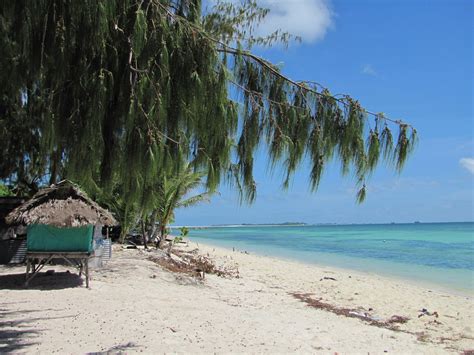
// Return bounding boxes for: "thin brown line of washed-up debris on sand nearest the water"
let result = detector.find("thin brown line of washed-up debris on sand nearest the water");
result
[290,292,410,330]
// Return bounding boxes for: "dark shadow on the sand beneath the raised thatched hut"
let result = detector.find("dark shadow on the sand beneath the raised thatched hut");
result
[0,271,84,290]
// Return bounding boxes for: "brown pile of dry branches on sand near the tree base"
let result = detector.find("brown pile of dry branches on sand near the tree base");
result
[148,249,239,279]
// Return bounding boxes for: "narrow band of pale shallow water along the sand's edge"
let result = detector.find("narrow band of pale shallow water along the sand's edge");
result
[188,236,474,299]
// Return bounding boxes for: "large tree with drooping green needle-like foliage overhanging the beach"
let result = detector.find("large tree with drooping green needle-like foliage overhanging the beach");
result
[0,0,416,220]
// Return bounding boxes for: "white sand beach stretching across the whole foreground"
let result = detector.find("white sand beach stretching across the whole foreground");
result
[0,243,474,354]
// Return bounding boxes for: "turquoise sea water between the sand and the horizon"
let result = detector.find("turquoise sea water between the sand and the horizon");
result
[185,222,474,293]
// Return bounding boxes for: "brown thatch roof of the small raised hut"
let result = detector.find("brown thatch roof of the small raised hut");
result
[5,180,118,227]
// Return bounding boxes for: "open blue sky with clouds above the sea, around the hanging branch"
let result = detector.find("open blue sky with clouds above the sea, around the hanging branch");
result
[175,0,474,225]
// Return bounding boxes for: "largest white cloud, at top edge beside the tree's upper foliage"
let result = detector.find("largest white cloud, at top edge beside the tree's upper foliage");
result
[257,0,333,42]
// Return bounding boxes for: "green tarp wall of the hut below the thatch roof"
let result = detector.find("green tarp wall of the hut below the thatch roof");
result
[27,224,94,252]
